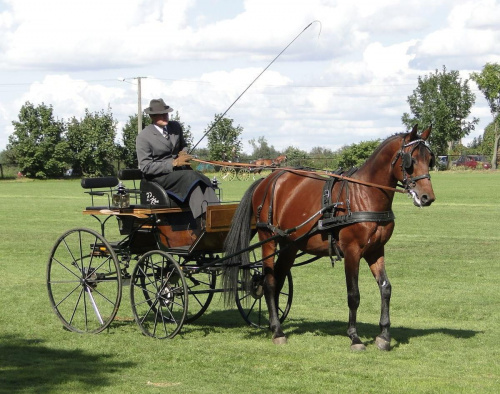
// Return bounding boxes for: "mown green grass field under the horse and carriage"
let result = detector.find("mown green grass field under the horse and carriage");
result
[0,171,500,393]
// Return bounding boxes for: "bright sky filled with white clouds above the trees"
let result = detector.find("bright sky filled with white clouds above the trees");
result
[0,0,500,153]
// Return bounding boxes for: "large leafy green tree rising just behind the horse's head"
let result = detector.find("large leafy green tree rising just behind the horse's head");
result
[401,66,479,155]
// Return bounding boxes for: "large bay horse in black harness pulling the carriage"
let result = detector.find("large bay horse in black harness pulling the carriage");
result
[223,125,435,350]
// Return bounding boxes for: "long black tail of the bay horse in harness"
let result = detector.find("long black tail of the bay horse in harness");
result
[222,179,264,305]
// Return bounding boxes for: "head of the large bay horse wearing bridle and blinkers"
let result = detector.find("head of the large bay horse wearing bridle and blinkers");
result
[392,125,436,207]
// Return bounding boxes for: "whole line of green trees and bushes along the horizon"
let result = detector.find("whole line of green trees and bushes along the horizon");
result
[0,63,500,178]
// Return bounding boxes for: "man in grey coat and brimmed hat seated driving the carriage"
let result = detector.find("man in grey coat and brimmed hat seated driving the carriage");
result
[136,98,219,218]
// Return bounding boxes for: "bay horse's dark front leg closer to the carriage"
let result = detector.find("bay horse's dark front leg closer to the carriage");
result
[344,253,366,351]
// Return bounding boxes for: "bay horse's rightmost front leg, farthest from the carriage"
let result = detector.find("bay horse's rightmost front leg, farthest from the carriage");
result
[366,248,392,350]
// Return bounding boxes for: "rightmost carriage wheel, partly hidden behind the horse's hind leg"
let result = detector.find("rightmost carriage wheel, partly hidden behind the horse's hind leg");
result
[236,252,293,328]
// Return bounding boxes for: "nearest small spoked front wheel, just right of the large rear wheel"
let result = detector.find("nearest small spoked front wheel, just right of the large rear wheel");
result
[130,250,188,339]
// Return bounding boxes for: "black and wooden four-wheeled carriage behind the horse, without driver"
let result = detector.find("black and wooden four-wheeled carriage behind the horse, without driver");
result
[47,169,293,338]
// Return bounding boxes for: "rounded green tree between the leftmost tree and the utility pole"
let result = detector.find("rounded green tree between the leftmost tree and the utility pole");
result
[67,108,118,176]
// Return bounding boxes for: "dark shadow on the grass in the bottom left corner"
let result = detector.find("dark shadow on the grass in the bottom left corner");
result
[0,335,135,393]
